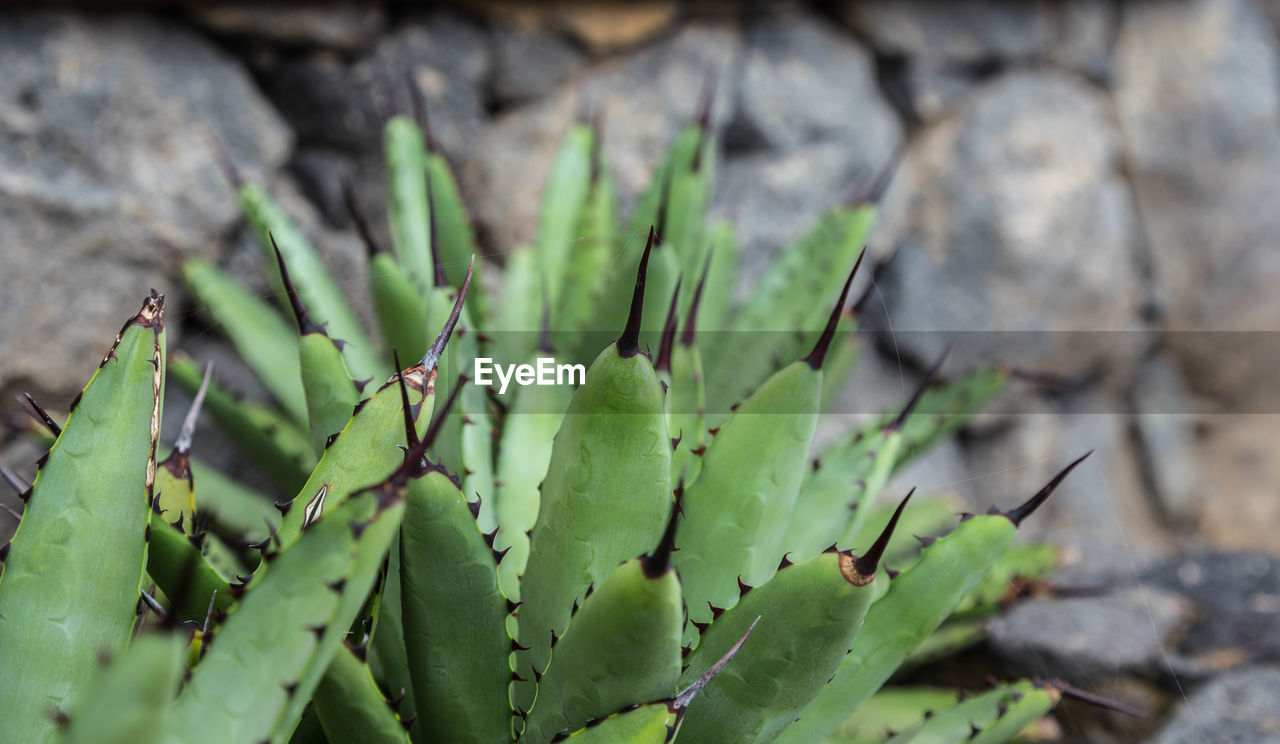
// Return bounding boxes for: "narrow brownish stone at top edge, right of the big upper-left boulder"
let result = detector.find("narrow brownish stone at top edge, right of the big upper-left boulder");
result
[188,0,387,50]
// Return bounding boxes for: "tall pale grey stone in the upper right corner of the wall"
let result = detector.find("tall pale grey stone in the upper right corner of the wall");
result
[1115,0,1280,411]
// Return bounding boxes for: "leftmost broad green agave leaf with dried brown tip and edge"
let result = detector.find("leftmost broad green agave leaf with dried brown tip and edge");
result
[0,295,165,741]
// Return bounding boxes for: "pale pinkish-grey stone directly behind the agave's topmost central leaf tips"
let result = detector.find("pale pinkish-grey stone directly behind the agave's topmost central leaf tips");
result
[460,23,740,251]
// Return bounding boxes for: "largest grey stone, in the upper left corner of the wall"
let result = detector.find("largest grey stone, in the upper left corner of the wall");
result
[0,13,289,394]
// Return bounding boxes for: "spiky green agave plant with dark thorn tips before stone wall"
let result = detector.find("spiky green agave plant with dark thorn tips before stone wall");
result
[0,105,1116,744]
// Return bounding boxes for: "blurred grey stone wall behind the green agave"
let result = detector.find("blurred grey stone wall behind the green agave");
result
[0,0,1280,743]
